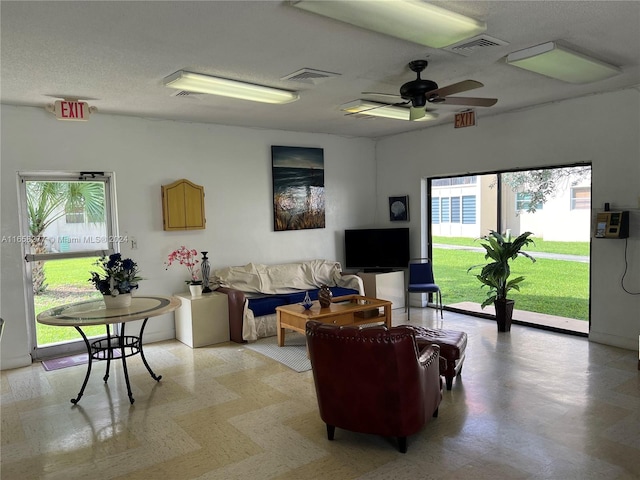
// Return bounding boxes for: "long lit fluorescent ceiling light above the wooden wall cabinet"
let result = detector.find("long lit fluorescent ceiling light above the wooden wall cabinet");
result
[163,70,300,103]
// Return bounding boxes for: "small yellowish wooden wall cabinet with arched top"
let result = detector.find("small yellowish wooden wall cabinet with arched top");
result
[162,178,206,230]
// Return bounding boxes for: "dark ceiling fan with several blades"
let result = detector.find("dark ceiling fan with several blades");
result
[362,60,498,120]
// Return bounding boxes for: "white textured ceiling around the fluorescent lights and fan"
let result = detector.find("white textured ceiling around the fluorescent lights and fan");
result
[0,0,640,137]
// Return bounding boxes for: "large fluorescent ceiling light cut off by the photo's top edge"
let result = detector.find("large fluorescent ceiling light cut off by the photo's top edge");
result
[291,0,487,48]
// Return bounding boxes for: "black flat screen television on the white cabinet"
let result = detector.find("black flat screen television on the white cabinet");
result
[344,228,410,272]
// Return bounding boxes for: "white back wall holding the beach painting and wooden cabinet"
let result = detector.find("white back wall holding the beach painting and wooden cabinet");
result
[0,105,376,369]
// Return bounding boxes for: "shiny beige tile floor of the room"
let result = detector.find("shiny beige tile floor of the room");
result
[0,309,640,480]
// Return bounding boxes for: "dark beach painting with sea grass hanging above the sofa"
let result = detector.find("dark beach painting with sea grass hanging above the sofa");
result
[271,146,325,232]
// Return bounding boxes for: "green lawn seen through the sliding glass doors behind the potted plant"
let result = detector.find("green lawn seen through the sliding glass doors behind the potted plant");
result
[432,237,589,320]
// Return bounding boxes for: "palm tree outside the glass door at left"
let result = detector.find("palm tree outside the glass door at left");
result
[26,181,105,295]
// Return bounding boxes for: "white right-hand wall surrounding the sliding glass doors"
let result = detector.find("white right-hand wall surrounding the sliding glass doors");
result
[376,89,640,350]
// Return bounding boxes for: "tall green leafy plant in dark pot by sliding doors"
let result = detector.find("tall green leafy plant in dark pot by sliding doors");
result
[467,230,536,332]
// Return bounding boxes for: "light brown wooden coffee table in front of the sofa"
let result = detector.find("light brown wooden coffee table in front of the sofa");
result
[276,295,391,347]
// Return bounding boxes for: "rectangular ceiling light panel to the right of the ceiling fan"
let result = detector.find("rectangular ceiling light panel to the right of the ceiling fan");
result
[507,42,621,83]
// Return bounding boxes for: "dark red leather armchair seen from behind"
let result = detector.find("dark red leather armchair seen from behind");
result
[306,321,442,453]
